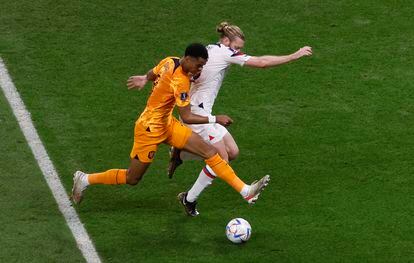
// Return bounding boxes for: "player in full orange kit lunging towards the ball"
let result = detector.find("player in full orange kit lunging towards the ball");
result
[72,43,270,208]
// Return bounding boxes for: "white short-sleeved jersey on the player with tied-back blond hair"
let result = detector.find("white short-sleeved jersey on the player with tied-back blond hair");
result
[190,43,250,116]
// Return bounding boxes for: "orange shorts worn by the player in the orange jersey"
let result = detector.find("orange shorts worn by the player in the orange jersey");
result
[130,118,192,163]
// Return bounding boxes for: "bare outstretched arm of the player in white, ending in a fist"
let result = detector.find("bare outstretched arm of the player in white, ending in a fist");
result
[244,46,312,68]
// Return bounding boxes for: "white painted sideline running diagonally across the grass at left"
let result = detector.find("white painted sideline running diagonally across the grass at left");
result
[0,57,101,262]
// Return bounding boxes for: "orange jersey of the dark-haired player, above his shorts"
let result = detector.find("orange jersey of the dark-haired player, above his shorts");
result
[137,57,190,131]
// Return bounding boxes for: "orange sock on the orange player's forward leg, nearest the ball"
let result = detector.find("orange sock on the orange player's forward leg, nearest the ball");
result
[205,153,246,193]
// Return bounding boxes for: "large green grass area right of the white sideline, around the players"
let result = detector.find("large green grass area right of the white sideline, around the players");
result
[0,0,414,262]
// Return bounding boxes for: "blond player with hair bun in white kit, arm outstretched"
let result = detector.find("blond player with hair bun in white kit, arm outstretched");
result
[168,22,312,216]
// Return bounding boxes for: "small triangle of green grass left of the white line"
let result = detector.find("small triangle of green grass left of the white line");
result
[0,82,82,262]
